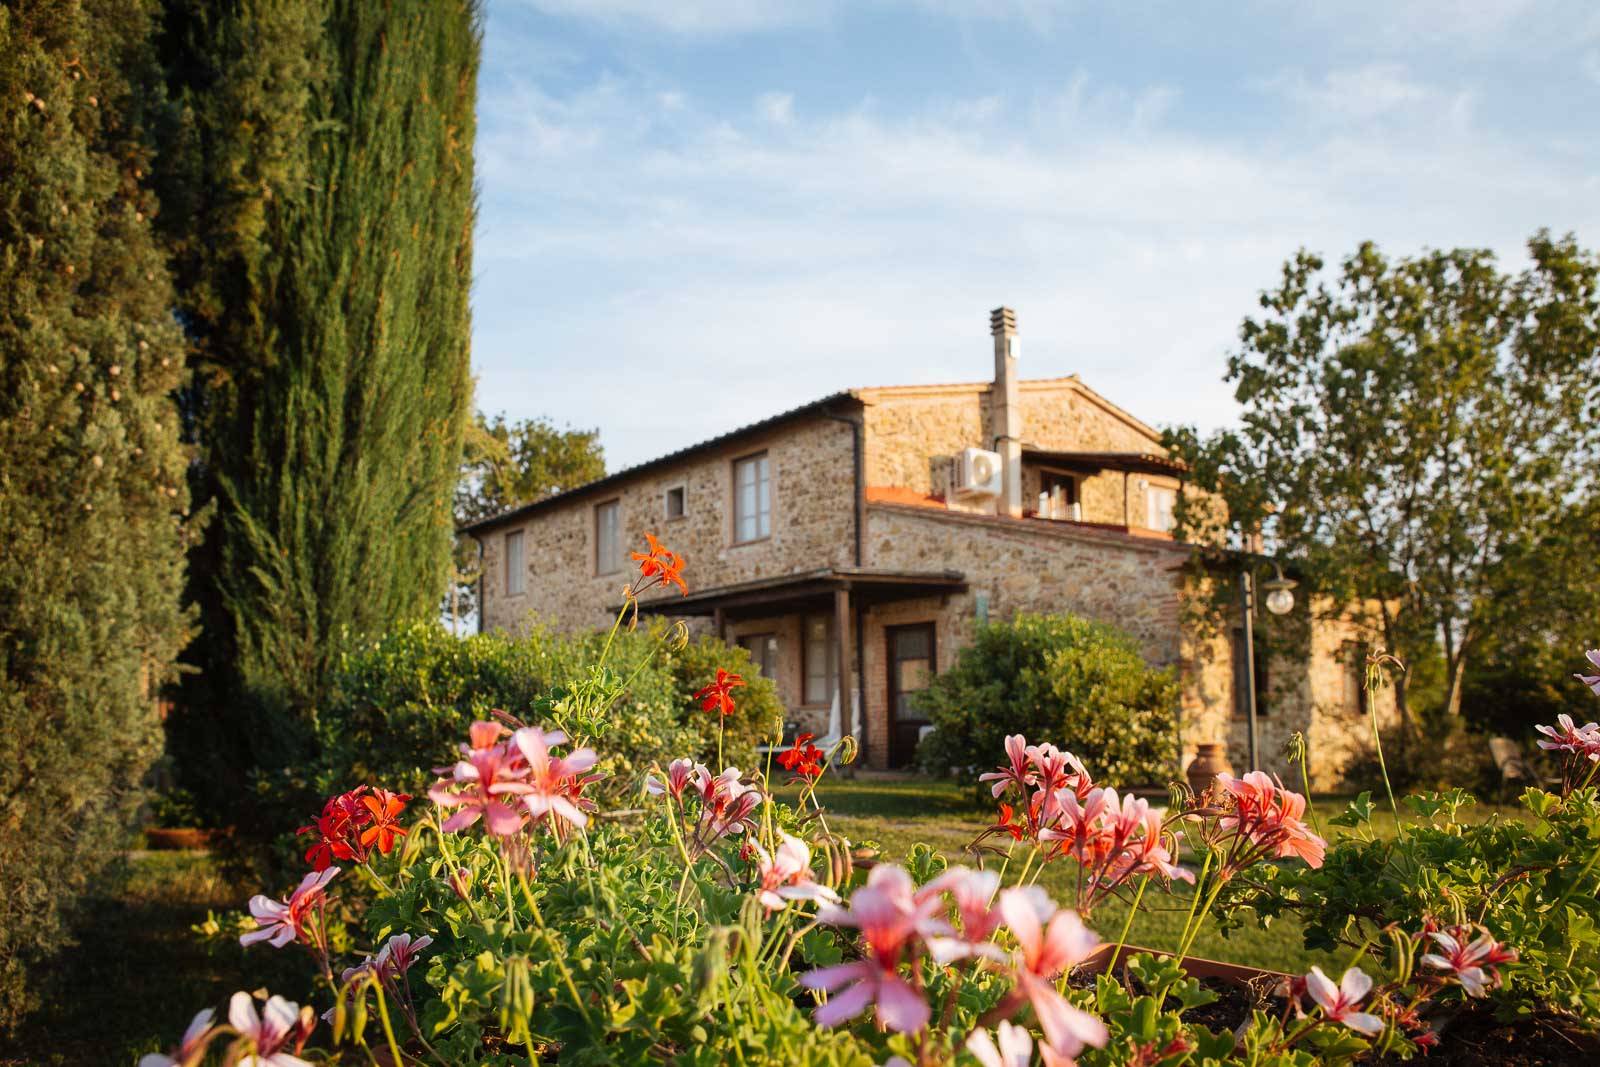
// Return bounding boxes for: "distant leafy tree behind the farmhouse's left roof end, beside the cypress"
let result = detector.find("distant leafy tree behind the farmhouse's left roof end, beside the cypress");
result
[445,413,605,629]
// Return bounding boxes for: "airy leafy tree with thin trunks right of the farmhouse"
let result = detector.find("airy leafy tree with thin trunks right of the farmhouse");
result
[1170,232,1600,735]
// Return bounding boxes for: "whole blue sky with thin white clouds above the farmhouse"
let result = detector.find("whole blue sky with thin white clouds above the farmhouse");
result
[472,0,1600,469]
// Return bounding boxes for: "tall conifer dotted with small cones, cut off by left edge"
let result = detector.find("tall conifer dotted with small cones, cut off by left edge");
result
[0,0,189,1032]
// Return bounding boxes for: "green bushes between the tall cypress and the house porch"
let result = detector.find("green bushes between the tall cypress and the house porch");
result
[307,622,782,814]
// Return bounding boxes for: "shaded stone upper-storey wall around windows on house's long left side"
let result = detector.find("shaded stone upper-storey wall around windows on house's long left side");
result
[480,418,854,630]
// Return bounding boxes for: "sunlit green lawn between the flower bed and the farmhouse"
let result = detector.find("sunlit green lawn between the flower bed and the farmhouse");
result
[784,776,1514,971]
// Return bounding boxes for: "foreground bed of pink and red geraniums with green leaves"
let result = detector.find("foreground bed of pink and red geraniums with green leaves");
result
[144,541,1600,1067]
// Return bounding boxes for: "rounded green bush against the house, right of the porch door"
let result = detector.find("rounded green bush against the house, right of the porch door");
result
[917,614,1178,784]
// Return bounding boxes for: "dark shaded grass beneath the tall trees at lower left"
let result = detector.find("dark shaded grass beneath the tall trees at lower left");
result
[0,853,312,1067]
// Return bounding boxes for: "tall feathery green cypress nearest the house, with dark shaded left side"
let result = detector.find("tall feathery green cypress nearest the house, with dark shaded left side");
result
[163,0,480,787]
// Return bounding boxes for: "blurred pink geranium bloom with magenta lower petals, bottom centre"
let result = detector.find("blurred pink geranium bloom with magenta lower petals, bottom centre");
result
[800,864,947,1033]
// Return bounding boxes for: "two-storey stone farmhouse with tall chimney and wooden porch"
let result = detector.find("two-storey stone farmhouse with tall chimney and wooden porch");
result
[464,307,1388,787]
